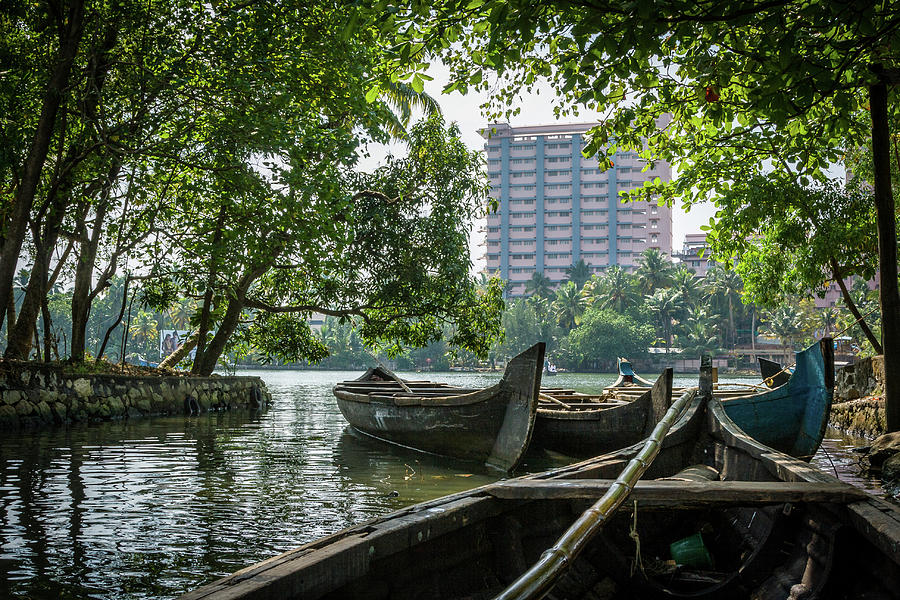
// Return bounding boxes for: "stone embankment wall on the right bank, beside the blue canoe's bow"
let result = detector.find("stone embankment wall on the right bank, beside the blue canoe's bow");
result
[830,356,885,437]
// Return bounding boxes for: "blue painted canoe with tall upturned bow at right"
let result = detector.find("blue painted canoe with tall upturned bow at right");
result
[722,338,834,460]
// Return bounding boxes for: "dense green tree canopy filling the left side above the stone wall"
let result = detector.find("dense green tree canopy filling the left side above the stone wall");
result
[0,0,502,373]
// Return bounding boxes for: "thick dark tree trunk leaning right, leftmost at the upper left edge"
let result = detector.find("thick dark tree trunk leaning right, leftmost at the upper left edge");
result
[0,0,84,324]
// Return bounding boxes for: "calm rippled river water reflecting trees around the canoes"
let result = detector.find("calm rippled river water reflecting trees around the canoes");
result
[0,371,873,600]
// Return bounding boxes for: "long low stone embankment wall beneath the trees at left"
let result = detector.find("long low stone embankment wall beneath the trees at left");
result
[0,363,271,428]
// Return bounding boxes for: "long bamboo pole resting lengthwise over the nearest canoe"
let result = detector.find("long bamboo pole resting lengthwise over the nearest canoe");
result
[494,369,697,600]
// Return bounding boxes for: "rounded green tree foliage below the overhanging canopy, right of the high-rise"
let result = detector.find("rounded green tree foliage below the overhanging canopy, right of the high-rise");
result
[708,175,878,308]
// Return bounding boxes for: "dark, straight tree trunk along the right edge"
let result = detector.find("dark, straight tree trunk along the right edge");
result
[869,82,900,432]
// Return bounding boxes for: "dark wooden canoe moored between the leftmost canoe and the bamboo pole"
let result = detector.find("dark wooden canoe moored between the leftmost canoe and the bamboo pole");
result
[531,368,672,457]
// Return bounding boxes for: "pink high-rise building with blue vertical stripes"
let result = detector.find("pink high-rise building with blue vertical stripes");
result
[482,123,672,296]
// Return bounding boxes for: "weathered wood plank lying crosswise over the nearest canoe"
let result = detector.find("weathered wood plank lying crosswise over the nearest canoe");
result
[485,479,868,508]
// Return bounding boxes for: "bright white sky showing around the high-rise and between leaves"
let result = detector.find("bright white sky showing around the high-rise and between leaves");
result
[361,65,715,271]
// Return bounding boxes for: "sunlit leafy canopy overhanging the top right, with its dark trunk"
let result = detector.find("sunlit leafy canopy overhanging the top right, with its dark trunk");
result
[385,0,900,430]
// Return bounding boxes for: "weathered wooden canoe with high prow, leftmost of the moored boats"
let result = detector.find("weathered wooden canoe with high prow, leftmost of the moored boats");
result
[333,342,544,471]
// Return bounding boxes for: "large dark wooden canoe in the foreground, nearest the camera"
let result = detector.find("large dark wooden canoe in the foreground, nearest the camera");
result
[184,368,900,600]
